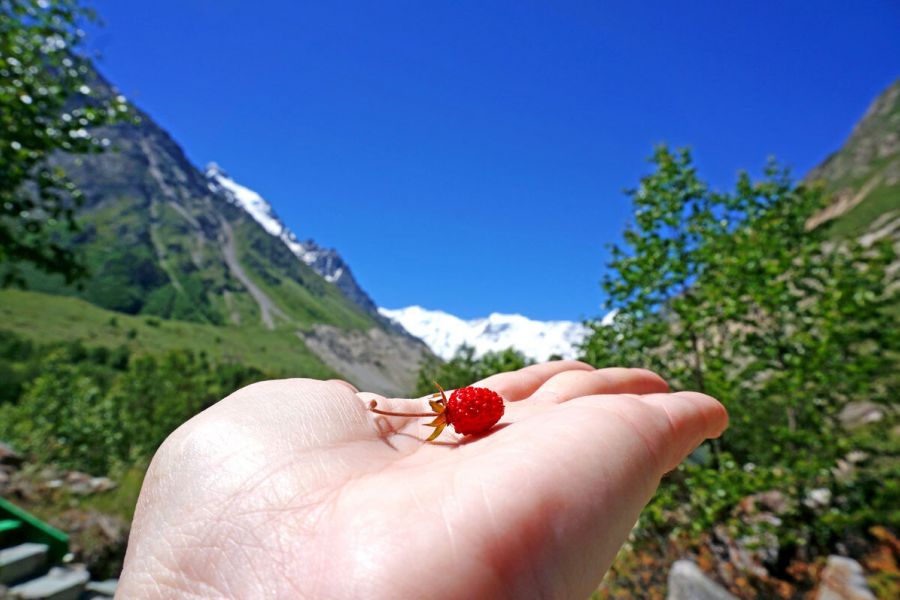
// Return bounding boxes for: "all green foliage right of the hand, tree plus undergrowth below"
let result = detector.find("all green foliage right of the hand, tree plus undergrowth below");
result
[583,146,900,597]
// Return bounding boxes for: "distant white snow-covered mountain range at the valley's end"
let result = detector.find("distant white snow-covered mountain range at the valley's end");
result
[378,306,588,361]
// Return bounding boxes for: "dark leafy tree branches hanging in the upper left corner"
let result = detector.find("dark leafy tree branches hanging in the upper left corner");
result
[0,0,129,285]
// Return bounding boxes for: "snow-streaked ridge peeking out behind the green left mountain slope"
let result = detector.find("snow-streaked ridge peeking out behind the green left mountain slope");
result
[205,163,377,314]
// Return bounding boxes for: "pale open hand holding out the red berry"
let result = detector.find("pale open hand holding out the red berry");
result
[119,361,728,599]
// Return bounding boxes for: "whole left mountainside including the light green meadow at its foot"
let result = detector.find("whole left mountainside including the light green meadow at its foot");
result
[0,58,430,394]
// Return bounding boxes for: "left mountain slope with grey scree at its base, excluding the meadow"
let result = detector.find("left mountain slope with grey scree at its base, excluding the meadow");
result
[5,65,429,394]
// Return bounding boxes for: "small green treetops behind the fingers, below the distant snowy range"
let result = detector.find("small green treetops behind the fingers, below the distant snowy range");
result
[415,345,534,396]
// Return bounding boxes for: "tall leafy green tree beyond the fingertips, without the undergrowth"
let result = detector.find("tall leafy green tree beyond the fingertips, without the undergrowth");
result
[584,147,898,464]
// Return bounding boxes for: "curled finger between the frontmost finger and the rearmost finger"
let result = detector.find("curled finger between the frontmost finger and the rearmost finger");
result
[528,367,669,404]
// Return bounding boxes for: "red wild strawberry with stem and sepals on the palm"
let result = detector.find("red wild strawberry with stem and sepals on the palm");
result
[369,383,503,442]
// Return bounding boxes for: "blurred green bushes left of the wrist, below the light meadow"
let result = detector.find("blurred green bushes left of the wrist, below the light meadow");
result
[0,332,271,475]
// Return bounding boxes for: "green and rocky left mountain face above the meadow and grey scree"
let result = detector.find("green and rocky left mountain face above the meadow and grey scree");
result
[29,72,375,328]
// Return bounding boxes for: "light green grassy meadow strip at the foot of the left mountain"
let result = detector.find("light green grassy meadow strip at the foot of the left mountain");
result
[0,290,339,379]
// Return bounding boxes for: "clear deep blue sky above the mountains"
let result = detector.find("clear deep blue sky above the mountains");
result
[90,0,900,319]
